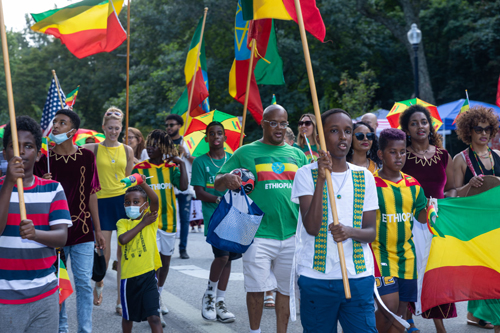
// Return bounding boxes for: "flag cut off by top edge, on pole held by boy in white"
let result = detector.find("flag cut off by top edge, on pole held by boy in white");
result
[241,0,326,42]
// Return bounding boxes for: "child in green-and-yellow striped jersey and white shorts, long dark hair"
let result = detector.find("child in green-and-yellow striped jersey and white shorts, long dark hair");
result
[132,129,188,323]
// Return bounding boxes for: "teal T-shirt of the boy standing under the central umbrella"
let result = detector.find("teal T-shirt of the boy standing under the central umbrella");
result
[191,153,231,236]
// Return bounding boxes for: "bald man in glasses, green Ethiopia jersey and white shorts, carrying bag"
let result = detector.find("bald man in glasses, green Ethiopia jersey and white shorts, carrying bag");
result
[215,104,308,333]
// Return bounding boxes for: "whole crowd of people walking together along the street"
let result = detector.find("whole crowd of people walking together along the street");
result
[0,104,500,333]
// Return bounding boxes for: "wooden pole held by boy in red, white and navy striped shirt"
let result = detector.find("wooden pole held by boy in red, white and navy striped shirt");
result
[0,0,26,221]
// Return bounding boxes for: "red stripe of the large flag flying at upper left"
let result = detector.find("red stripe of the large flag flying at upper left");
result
[45,13,127,59]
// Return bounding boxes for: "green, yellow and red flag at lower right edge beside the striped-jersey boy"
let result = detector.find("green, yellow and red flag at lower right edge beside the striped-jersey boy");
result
[420,187,500,311]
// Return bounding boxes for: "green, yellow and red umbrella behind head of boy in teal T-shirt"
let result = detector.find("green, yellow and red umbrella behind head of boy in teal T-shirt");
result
[184,110,241,157]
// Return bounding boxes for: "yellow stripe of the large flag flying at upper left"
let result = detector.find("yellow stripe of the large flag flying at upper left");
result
[31,0,123,35]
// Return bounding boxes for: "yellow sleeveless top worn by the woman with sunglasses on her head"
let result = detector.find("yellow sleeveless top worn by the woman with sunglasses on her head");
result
[96,144,127,199]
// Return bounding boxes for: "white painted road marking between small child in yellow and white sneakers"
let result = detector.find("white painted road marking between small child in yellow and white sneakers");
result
[162,288,236,333]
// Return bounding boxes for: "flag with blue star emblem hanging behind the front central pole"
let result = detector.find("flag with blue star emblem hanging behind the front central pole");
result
[229,3,272,124]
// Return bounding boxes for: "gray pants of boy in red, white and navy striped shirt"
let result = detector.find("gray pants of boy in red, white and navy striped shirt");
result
[0,291,59,333]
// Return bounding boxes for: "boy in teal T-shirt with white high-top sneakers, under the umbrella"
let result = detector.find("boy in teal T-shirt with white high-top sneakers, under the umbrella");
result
[191,121,241,323]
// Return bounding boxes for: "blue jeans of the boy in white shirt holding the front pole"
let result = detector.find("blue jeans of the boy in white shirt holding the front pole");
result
[298,276,377,333]
